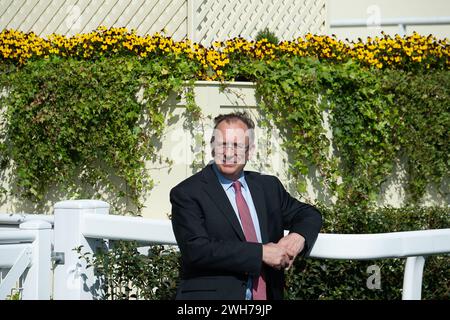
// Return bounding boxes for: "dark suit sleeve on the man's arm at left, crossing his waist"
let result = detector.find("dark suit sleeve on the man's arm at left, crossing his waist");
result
[170,187,262,276]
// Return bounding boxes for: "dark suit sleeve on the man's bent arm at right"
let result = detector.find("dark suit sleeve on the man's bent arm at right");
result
[276,178,322,256]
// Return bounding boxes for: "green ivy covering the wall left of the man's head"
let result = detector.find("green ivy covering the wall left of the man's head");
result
[1,57,198,209]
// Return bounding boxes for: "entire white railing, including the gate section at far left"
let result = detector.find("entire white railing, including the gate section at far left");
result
[0,200,450,300]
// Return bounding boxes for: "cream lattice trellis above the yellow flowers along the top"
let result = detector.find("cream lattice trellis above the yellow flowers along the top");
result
[0,0,326,45]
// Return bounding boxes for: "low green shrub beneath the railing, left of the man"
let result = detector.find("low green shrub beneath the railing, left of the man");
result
[76,241,179,300]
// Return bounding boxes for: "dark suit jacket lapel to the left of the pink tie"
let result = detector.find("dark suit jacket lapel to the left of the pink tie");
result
[203,165,245,241]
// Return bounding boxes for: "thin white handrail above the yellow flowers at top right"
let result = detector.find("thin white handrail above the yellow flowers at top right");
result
[330,17,450,35]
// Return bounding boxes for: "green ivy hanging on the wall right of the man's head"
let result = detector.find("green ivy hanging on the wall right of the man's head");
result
[250,57,450,205]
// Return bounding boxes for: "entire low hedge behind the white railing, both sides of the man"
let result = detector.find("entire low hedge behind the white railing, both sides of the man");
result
[84,207,450,300]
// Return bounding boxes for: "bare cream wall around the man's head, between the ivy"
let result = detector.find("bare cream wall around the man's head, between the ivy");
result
[144,81,302,217]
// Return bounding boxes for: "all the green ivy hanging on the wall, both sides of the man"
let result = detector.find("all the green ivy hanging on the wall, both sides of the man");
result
[0,48,450,210]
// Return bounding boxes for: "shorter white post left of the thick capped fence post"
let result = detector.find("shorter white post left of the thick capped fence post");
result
[19,220,53,300]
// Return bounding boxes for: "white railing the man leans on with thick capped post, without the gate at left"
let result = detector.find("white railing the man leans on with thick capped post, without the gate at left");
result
[55,201,450,299]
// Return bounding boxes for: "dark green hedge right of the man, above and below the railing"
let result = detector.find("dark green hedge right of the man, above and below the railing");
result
[286,207,450,300]
